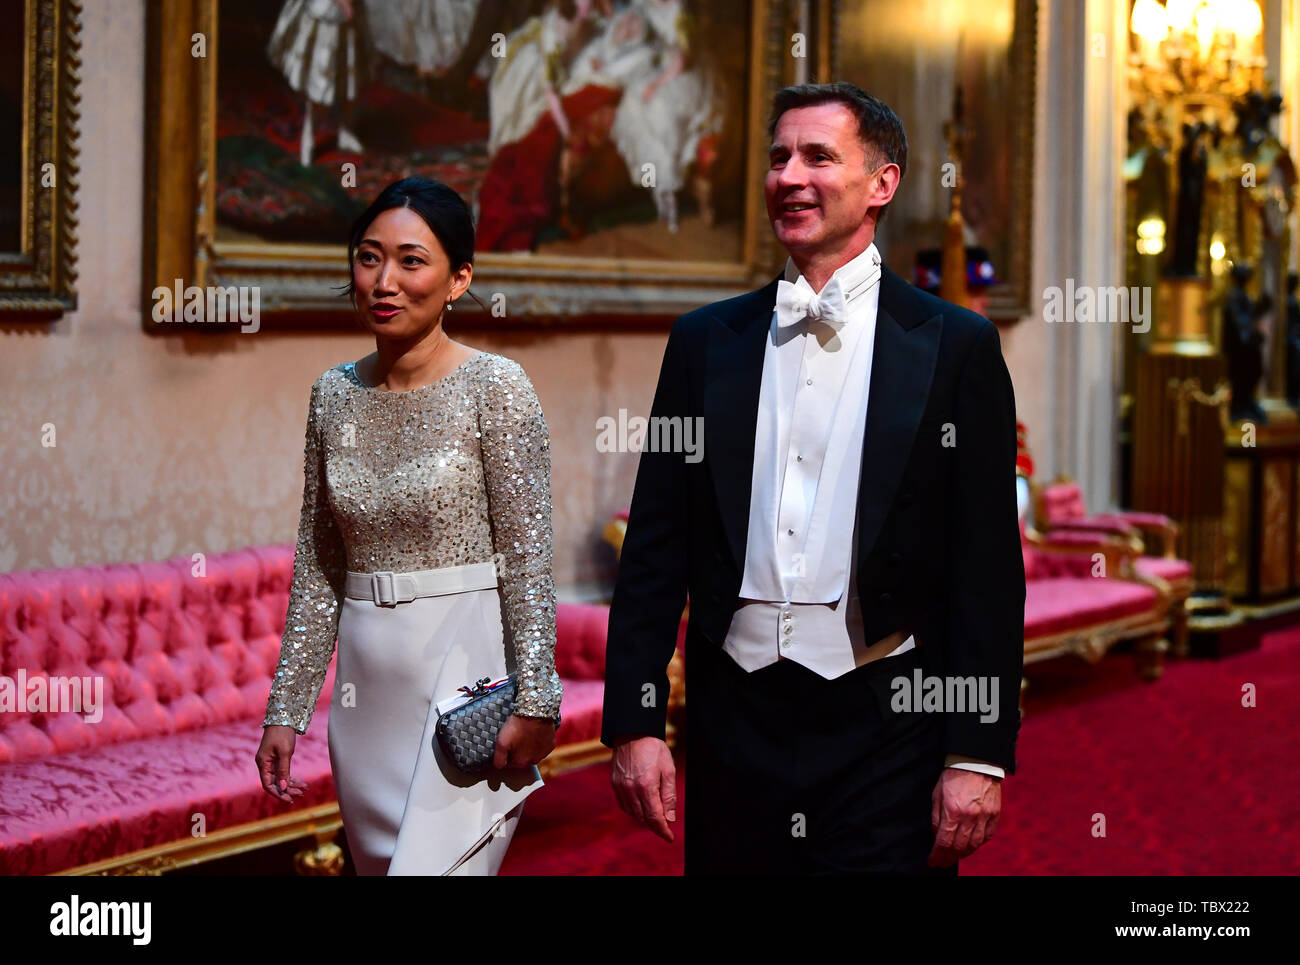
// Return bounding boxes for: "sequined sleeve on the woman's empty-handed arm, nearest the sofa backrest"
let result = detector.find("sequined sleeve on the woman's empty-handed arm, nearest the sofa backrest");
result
[263,376,347,734]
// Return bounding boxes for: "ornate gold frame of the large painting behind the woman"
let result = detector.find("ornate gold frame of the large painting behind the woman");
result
[143,0,811,333]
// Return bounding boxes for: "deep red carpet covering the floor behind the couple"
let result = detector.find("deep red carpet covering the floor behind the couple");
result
[502,627,1300,875]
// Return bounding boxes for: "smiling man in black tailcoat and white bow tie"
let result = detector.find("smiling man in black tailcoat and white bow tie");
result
[602,83,1024,875]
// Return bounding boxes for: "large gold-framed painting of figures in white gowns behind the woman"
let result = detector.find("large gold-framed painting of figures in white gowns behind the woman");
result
[144,0,811,329]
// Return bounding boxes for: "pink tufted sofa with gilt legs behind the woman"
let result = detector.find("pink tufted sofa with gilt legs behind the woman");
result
[0,545,607,874]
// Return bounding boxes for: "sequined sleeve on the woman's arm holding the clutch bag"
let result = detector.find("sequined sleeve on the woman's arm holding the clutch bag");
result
[478,359,563,717]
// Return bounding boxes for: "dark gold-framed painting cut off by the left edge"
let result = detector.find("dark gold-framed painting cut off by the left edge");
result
[0,0,81,321]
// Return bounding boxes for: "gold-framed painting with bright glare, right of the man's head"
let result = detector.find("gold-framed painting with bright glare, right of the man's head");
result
[833,0,1037,321]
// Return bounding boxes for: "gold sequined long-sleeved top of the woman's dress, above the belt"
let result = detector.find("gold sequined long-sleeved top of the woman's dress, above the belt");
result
[264,351,560,734]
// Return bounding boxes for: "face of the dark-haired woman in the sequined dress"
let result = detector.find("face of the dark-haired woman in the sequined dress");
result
[352,208,473,338]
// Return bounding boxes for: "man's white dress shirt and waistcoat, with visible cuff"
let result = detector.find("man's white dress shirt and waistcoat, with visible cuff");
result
[723,243,1005,778]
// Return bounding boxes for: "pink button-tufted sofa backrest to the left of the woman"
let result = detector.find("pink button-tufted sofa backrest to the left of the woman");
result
[0,545,309,763]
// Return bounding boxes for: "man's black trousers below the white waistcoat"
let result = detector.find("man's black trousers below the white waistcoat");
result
[683,644,957,875]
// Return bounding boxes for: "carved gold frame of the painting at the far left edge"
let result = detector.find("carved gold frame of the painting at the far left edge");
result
[0,0,82,321]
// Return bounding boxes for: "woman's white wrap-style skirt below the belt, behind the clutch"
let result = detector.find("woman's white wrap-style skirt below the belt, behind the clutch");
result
[328,564,542,875]
